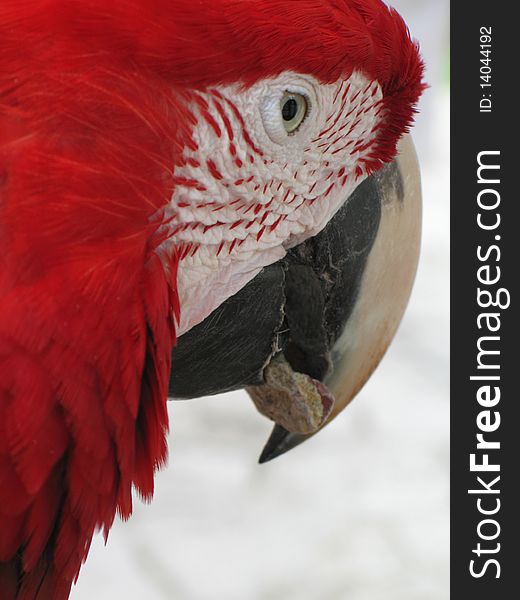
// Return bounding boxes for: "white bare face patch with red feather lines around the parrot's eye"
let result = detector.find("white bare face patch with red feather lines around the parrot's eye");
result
[166,72,384,335]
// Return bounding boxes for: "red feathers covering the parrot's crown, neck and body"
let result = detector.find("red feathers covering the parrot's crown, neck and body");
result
[0,0,422,600]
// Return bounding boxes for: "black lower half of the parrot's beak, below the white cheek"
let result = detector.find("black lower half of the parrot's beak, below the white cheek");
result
[169,261,287,399]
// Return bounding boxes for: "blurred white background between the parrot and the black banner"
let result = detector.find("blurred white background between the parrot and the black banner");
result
[72,0,449,600]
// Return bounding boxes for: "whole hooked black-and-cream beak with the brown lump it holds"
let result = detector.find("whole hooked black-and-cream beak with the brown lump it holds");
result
[170,136,421,462]
